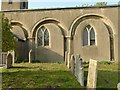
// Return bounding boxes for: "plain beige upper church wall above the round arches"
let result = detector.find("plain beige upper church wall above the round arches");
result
[5,8,118,32]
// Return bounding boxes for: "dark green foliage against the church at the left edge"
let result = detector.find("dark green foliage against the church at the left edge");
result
[1,14,15,52]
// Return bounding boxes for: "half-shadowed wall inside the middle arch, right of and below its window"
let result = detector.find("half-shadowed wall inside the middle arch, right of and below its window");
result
[35,23,64,62]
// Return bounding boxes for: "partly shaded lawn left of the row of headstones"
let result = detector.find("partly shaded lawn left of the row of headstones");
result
[2,63,80,88]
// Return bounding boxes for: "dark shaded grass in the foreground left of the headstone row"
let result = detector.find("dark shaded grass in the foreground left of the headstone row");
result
[2,70,81,88]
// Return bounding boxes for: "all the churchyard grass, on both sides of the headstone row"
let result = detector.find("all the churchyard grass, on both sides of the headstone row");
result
[2,63,120,89]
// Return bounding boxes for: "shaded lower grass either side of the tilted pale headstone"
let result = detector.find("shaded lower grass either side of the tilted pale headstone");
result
[84,70,119,90]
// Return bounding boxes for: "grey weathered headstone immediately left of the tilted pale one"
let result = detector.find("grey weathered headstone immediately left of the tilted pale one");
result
[77,58,84,86]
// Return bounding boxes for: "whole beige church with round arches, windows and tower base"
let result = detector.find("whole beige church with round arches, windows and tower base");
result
[1,0,120,62]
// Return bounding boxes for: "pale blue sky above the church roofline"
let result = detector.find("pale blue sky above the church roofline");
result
[0,0,119,9]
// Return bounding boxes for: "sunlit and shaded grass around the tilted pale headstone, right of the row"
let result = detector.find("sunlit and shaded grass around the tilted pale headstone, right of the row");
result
[85,61,120,90]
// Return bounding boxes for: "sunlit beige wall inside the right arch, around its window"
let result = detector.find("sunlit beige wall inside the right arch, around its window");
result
[73,19,110,61]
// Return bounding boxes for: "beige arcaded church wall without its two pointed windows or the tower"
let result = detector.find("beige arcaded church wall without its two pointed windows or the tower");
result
[4,6,119,62]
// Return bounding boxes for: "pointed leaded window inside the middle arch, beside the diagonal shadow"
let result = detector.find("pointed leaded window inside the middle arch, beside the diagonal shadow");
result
[37,26,49,46]
